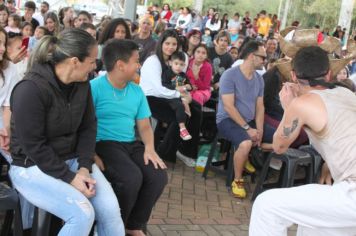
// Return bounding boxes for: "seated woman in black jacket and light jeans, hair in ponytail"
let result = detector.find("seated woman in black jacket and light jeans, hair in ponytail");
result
[9,29,125,236]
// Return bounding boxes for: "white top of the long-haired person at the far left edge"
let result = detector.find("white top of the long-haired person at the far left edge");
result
[0,62,21,128]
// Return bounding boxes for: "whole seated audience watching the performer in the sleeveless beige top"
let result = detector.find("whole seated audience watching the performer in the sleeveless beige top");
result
[0,1,355,236]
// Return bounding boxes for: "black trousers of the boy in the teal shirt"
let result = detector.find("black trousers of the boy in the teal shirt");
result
[95,141,168,230]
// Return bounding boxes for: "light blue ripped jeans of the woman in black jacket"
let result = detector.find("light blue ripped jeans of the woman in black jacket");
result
[9,159,125,236]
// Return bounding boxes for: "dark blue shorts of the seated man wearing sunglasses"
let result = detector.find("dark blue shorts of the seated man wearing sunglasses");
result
[217,118,275,147]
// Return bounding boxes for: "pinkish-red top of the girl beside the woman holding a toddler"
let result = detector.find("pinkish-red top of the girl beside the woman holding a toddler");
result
[186,58,213,90]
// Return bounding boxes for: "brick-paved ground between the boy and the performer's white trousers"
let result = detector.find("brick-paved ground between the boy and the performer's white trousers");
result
[148,161,295,236]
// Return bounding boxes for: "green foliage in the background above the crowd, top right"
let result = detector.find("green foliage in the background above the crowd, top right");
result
[145,0,356,31]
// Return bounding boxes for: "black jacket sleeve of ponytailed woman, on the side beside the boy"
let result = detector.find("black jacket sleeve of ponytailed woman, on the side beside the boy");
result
[76,86,96,172]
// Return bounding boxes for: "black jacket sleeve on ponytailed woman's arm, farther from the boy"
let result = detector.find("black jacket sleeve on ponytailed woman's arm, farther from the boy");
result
[11,81,75,183]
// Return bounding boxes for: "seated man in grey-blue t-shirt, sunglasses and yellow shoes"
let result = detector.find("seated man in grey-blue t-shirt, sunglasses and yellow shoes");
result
[216,41,272,198]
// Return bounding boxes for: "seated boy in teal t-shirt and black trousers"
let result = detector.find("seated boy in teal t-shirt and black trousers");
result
[90,39,167,235]
